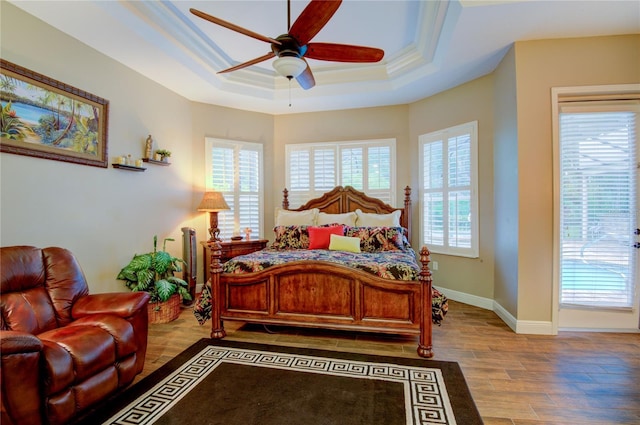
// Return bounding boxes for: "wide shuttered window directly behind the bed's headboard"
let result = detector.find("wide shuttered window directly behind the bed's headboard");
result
[286,139,396,208]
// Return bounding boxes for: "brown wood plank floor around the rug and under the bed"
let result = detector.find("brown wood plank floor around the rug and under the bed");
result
[137,301,640,425]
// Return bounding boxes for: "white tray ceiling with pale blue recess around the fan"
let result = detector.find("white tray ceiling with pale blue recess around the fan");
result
[10,0,640,114]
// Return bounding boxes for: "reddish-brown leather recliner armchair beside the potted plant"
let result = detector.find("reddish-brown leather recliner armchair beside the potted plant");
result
[0,246,149,425]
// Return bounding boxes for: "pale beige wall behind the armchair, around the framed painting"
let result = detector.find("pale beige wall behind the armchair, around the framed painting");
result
[0,2,200,292]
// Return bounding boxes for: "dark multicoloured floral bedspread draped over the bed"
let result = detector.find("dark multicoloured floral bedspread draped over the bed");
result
[194,248,448,325]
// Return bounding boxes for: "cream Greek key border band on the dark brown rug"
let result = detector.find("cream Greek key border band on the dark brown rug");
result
[104,346,456,425]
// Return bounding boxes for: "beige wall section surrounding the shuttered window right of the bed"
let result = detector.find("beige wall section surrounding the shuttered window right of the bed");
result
[405,76,494,299]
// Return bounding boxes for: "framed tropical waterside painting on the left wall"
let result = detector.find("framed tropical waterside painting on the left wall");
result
[0,59,109,168]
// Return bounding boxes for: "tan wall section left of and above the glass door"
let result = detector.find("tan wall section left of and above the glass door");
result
[512,35,640,321]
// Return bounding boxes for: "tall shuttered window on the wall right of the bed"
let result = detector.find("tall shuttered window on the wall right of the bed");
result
[419,121,478,258]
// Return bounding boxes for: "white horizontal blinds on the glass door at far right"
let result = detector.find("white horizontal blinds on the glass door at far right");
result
[559,102,638,308]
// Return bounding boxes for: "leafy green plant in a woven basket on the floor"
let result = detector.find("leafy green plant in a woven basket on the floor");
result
[117,236,191,323]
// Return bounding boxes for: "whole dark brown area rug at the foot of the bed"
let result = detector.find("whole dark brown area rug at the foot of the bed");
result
[76,338,482,425]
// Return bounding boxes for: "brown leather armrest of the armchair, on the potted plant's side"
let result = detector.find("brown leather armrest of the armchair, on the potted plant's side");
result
[71,292,150,319]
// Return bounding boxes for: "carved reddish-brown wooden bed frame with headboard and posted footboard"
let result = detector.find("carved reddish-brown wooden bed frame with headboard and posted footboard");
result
[208,186,433,357]
